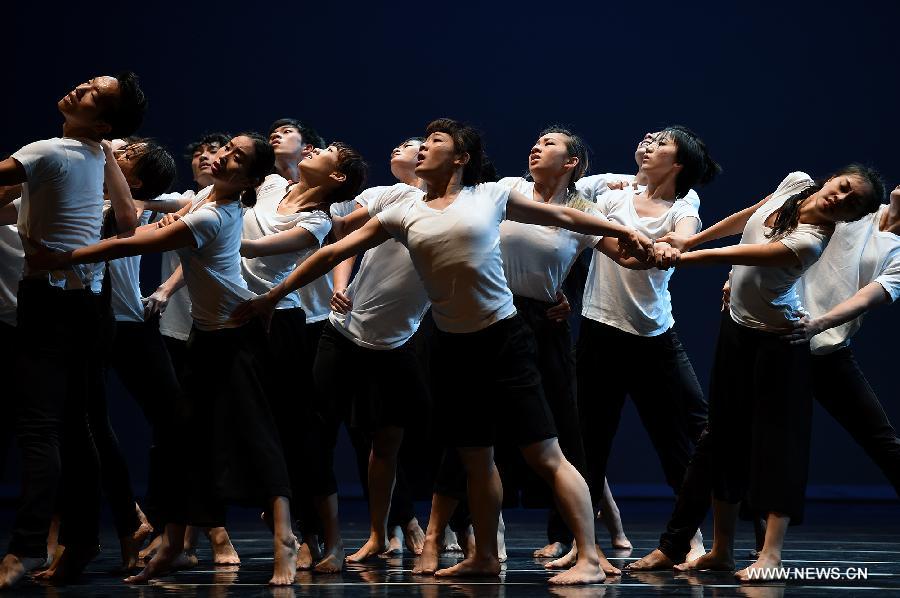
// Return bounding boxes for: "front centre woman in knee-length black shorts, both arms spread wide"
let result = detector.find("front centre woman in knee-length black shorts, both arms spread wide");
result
[235,119,651,584]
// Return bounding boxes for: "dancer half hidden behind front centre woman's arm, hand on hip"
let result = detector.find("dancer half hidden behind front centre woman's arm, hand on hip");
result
[314,139,429,568]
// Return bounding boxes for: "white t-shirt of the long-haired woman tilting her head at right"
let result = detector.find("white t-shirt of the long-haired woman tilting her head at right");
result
[731,172,832,332]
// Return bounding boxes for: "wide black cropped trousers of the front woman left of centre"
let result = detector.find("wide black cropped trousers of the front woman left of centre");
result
[168,321,291,527]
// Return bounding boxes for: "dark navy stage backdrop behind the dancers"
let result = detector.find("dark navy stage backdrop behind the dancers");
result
[0,1,900,497]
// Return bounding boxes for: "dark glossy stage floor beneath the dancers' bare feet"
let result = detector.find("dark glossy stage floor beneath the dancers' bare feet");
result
[0,500,900,598]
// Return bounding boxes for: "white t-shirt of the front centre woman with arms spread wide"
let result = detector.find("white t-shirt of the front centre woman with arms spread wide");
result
[377,183,516,333]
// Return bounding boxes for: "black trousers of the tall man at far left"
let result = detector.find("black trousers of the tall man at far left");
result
[9,280,102,558]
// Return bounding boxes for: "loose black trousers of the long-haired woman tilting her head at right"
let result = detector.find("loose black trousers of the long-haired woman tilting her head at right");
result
[709,312,812,523]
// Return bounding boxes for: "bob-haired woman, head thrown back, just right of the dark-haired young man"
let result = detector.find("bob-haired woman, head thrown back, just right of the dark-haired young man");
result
[241,142,367,572]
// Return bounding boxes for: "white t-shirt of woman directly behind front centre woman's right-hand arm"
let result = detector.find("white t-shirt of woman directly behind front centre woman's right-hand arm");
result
[498,177,603,303]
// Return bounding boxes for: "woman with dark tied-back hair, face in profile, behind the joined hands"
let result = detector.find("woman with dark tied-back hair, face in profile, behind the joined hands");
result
[563,126,719,563]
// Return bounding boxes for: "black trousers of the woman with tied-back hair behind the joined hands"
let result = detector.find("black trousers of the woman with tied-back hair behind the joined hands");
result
[577,318,706,508]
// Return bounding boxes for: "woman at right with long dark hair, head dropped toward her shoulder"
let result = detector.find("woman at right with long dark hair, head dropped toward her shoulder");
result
[658,165,884,580]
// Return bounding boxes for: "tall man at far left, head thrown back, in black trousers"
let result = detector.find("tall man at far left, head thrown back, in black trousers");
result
[0,73,146,588]
